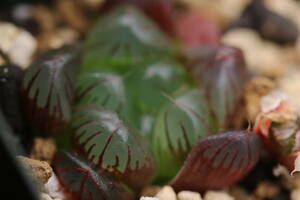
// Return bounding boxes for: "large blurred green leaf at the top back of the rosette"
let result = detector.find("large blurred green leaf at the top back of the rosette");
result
[83,6,170,73]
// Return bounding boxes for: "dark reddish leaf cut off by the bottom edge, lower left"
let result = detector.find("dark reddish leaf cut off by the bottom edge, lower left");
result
[54,152,134,200]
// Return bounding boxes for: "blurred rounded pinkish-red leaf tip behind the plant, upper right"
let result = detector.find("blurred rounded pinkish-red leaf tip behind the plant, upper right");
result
[175,12,220,47]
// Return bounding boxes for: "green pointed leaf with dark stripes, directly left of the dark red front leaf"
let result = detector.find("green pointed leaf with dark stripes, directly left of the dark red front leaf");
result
[153,89,210,180]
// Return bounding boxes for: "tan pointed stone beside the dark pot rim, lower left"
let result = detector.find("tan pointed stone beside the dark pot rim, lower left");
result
[18,156,53,184]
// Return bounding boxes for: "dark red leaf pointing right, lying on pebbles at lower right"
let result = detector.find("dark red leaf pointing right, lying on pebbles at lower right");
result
[171,131,261,191]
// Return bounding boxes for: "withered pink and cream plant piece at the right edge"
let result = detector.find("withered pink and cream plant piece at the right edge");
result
[253,91,300,172]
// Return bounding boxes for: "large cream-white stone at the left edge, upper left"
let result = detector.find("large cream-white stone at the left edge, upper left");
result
[0,22,37,68]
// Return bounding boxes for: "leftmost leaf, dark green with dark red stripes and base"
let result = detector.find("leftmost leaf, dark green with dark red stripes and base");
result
[22,46,80,135]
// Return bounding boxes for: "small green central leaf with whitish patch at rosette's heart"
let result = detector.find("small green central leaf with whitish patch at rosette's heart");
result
[125,60,186,137]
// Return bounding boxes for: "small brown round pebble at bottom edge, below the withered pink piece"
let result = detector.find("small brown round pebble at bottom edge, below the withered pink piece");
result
[254,181,280,198]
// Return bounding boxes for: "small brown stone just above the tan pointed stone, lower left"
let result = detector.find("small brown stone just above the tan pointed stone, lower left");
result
[30,137,57,164]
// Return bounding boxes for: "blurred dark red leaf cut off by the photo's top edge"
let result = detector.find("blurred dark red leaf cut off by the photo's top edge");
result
[103,0,175,36]
